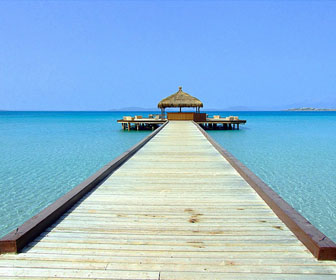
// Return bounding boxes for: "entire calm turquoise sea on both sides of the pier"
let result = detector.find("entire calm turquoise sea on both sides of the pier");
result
[0,112,336,241]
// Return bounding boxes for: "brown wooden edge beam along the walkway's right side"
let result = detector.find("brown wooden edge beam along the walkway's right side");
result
[194,122,336,260]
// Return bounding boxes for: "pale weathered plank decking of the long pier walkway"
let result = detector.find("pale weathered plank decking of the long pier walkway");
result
[0,122,336,279]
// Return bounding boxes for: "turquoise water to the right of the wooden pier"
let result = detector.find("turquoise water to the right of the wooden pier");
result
[208,112,336,241]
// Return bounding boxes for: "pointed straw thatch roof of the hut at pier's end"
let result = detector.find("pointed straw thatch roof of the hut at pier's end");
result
[158,87,203,108]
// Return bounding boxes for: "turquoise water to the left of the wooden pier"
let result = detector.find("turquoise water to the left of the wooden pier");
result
[0,112,150,236]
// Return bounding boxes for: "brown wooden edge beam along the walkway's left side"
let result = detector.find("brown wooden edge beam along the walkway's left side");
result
[0,121,168,254]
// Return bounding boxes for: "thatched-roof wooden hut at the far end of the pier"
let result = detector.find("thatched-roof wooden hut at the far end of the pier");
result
[158,87,206,121]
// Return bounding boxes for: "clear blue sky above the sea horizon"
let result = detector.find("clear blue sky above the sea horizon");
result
[0,1,336,110]
